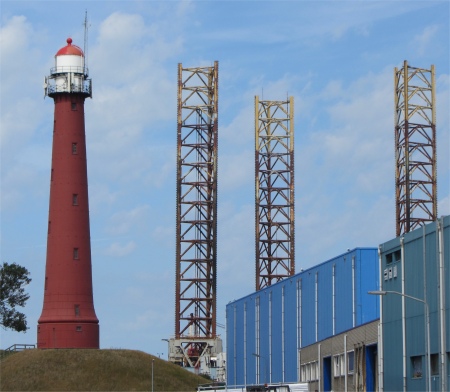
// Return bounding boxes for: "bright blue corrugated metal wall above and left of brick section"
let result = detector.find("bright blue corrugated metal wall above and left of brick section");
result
[227,248,379,386]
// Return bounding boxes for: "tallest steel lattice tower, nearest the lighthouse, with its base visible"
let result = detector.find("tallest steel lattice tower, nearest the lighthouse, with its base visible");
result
[169,61,221,367]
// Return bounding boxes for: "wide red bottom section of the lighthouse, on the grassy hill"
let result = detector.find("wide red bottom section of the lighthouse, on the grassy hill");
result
[37,323,100,349]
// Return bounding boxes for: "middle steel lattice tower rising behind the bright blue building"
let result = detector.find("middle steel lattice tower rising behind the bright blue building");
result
[255,96,295,290]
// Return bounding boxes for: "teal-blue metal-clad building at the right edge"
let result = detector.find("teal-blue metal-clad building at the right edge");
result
[379,216,450,391]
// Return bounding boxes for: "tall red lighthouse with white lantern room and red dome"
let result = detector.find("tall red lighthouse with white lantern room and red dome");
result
[37,38,99,348]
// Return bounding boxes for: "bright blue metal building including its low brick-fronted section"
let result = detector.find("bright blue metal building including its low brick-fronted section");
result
[226,248,380,390]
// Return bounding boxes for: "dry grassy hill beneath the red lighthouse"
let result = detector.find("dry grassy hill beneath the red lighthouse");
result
[0,349,208,392]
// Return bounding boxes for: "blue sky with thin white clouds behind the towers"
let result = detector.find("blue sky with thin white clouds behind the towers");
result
[0,0,450,357]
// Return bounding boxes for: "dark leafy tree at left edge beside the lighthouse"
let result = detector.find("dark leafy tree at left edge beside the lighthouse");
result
[0,263,31,332]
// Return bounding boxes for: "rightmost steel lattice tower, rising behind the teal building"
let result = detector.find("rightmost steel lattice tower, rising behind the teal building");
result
[394,61,437,236]
